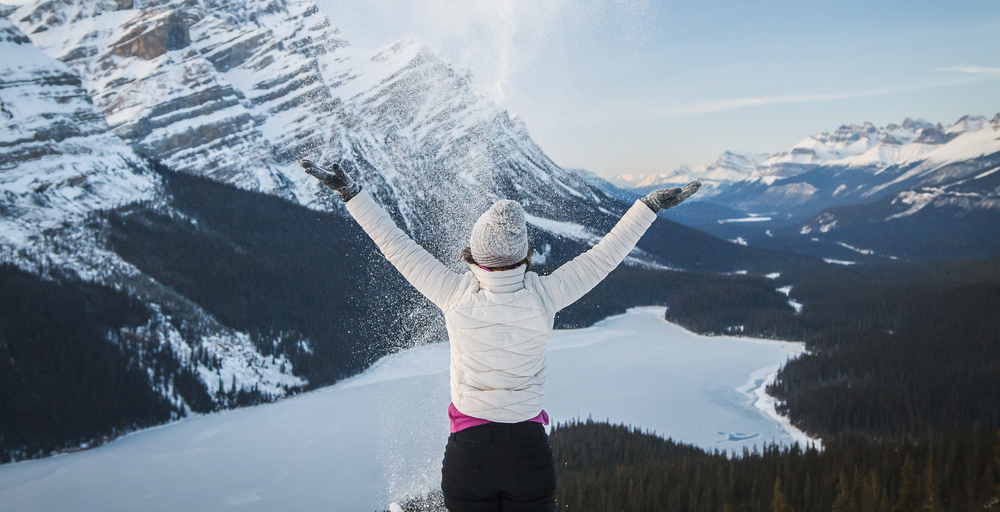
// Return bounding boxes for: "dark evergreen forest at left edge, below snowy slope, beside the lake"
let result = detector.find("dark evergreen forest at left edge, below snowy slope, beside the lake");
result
[0,265,179,463]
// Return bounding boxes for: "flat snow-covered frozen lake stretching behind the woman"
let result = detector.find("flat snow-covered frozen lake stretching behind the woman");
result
[0,308,806,512]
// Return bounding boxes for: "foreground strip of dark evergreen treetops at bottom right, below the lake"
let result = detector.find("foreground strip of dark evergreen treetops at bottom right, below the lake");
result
[550,420,1000,512]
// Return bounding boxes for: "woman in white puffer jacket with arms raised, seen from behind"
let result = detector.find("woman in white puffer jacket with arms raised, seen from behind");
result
[302,160,701,512]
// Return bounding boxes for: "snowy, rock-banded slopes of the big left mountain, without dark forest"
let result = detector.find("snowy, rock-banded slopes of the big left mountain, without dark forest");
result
[0,0,624,416]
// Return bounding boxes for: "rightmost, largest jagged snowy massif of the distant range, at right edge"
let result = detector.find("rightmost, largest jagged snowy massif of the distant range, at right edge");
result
[719,114,1000,216]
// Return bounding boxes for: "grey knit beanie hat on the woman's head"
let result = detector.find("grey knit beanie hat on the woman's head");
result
[469,199,528,268]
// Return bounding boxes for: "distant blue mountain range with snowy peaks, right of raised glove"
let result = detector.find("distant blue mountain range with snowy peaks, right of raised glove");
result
[612,114,1000,263]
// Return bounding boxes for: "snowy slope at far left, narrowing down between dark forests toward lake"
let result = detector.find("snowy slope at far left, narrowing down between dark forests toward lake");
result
[0,18,305,410]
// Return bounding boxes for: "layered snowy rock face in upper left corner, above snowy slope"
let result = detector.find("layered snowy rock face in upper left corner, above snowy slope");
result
[0,18,157,250]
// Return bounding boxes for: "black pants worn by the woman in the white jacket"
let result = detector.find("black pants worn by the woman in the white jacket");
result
[441,421,556,512]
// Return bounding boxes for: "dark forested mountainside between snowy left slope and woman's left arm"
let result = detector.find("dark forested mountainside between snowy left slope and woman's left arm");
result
[107,165,437,390]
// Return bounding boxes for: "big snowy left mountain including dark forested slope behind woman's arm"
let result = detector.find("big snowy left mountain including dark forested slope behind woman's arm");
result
[0,0,764,460]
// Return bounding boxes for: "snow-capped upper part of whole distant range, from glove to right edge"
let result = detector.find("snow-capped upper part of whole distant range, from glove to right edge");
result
[613,114,1000,211]
